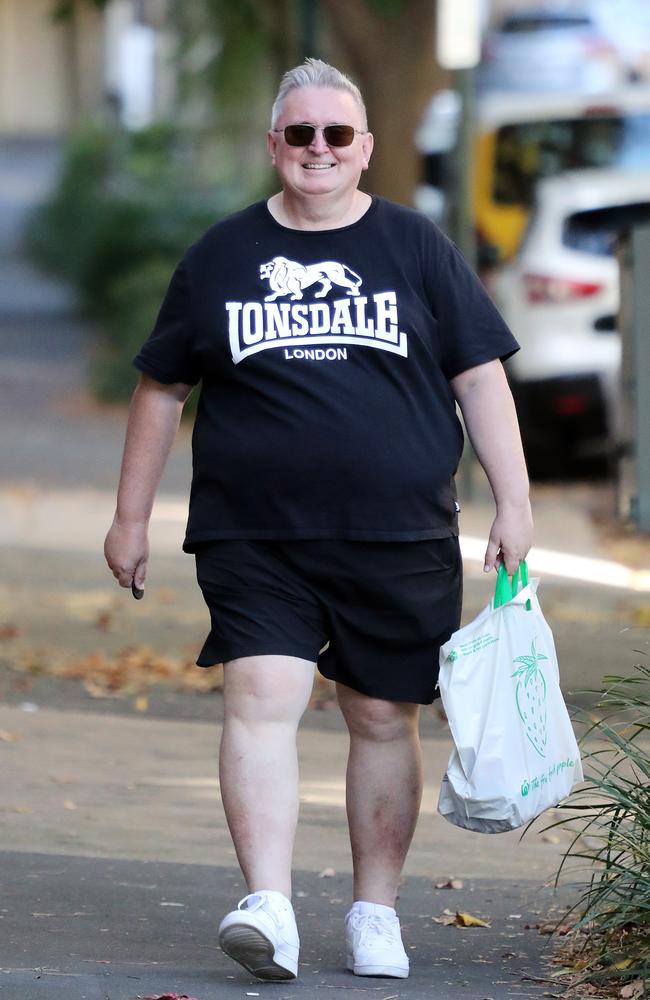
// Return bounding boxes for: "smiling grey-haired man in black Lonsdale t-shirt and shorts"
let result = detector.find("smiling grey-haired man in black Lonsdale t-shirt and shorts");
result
[106,59,532,980]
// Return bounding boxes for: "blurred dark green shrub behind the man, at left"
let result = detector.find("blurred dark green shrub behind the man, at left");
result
[25,123,251,399]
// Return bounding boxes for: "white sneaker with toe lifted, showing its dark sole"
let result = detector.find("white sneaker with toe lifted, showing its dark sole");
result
[219,889,300,982]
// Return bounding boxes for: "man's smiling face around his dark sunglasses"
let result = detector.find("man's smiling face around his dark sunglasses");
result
[267,87,373,206]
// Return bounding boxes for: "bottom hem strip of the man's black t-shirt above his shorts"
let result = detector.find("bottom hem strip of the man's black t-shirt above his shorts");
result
[183,525,458,553]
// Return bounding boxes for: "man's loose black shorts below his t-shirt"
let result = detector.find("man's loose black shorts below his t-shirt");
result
[196,537,462,705]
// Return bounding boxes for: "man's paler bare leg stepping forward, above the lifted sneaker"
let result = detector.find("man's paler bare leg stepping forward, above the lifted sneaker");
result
[219,656,314,898]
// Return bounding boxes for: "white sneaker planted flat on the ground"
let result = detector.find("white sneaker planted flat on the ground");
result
[345,903,409,979]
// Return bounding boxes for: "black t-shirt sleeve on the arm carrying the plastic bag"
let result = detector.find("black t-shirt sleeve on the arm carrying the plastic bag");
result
[433,237,519,379]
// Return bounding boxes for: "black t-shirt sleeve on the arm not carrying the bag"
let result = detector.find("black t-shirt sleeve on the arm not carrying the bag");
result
[133,261,201,385]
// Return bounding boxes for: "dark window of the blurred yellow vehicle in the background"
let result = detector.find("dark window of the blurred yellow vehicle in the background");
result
[493,113,650,207]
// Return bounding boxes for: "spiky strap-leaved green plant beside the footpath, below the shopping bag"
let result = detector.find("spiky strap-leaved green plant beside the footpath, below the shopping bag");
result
[552,664,650,984]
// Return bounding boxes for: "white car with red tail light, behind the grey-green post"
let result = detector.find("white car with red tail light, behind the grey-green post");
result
[493,169,650,475]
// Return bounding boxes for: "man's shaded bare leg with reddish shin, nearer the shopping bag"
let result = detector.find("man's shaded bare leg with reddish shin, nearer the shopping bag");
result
[337,684,422,906]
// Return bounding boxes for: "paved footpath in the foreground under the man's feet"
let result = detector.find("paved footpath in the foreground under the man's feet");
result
[0,695,568,1000]
